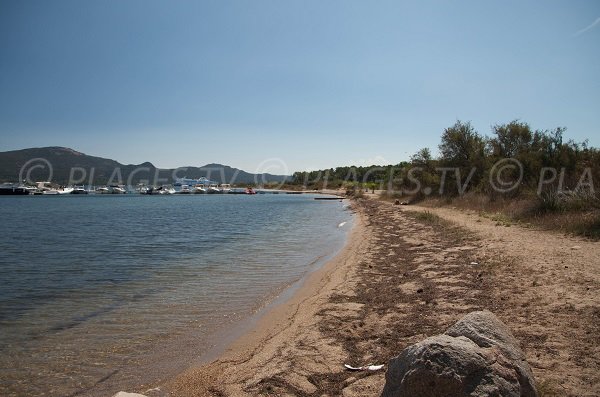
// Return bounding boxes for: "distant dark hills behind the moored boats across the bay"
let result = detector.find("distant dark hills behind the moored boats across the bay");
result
[0,147,289,185]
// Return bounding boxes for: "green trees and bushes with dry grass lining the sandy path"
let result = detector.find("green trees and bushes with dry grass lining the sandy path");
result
[292,120,600,239]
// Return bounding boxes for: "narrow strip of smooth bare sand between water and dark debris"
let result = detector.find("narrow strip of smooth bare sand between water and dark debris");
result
[162,206,366,397]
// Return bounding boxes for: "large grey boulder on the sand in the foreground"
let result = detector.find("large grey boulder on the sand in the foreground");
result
[381,311,537,397]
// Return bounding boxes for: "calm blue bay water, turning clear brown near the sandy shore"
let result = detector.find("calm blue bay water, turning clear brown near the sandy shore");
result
[0,195,351,396]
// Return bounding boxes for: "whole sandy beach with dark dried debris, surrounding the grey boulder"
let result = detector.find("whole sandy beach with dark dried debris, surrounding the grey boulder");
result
[159,198,600,397]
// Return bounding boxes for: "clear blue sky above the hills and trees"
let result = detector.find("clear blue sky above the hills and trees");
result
[0,0,600,173]
